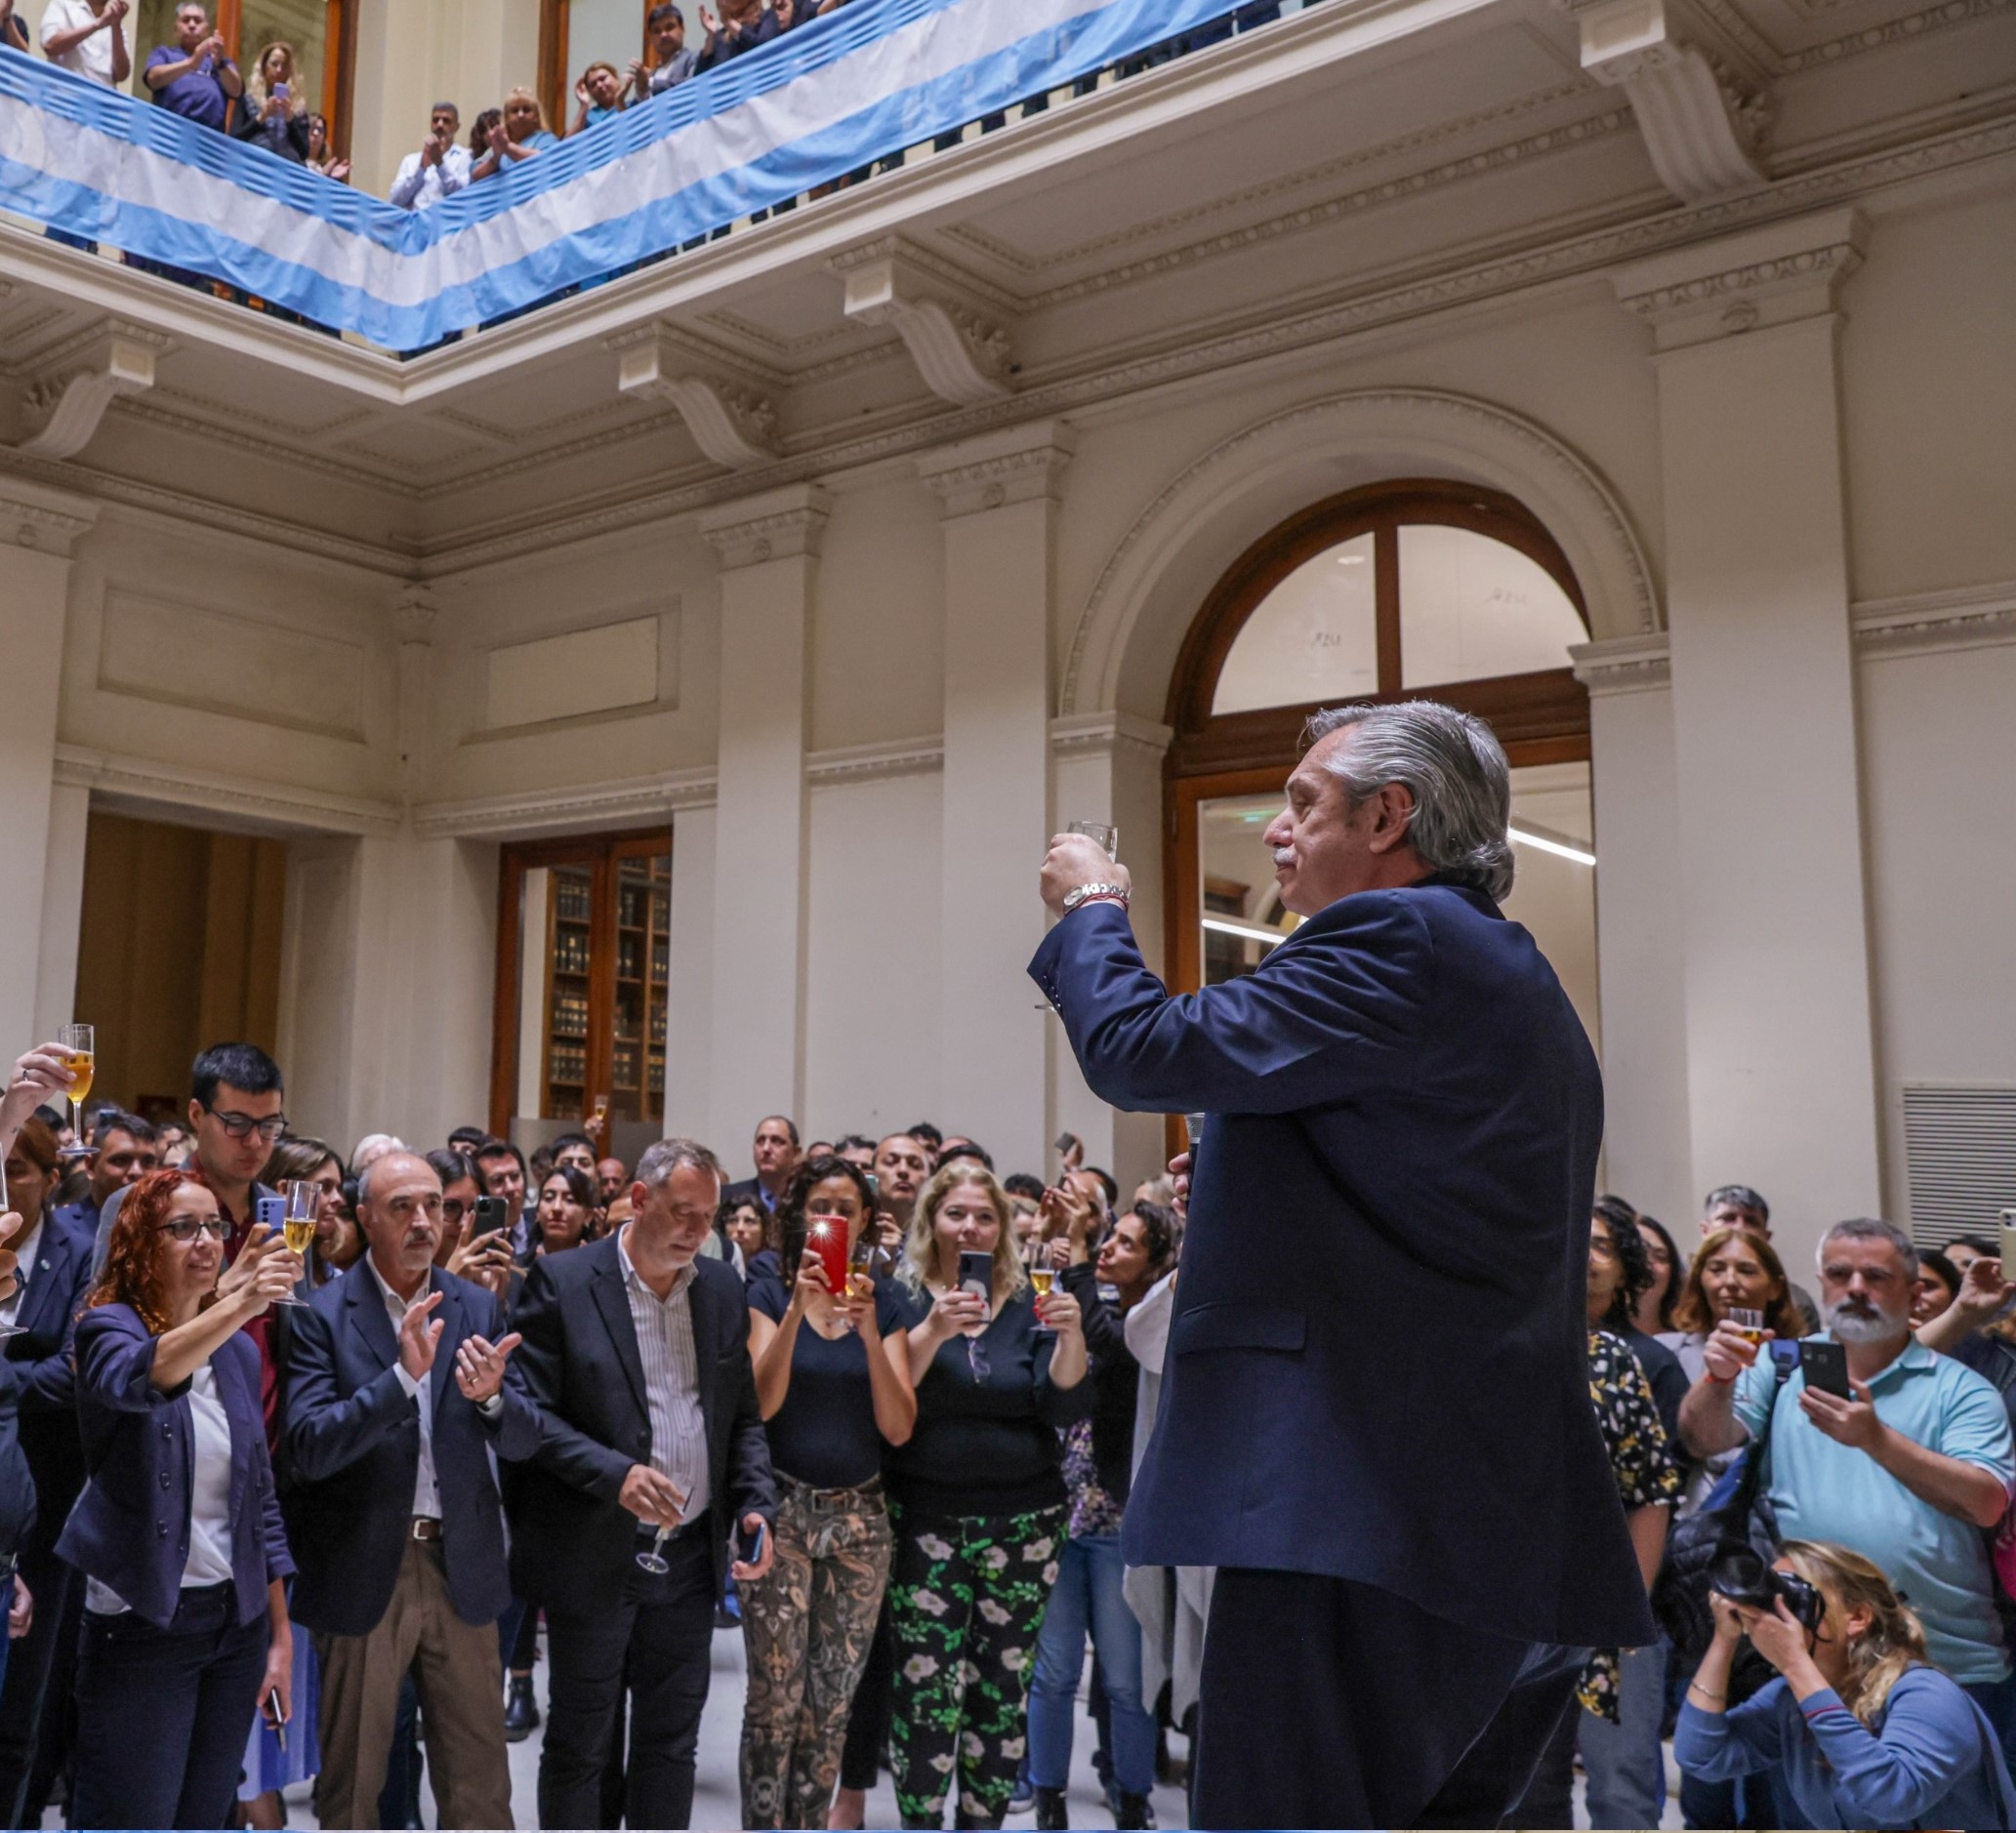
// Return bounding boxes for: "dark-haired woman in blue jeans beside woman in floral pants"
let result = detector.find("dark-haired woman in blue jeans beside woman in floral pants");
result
[1028,1203,1175,1827]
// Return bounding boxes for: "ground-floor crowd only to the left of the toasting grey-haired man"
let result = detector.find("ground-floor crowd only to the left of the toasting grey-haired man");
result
[0,1044,1181,1827]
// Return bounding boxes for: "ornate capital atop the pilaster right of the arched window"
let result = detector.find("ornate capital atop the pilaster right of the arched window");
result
[1613,208,1869,350]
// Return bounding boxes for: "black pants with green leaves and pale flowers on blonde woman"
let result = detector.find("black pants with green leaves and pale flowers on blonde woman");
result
[889,1508,1064,1827]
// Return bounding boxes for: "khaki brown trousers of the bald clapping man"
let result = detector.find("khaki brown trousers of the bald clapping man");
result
[314,1540,513,1827]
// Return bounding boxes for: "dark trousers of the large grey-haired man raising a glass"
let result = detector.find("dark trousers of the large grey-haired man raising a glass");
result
[1193,1567,1579,1827]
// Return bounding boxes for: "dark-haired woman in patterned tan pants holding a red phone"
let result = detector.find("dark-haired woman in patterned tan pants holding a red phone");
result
[738,1154,918,1827]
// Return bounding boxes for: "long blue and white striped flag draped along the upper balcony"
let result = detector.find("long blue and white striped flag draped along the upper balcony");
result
[0,0,1308,357]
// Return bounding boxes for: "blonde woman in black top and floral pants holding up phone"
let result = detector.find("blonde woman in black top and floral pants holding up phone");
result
[885,1160,1090,1827]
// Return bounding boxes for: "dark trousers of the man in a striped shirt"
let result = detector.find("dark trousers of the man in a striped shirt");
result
[538,1519,714,1827]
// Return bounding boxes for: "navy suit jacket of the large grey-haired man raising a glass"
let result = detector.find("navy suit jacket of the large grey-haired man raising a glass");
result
[1030,881,1653,1646]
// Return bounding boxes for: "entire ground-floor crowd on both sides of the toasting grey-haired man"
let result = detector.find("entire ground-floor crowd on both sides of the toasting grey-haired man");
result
[0,1024,2016,1827]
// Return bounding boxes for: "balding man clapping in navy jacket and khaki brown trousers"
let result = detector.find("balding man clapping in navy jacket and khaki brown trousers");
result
[286,1152,538,1827]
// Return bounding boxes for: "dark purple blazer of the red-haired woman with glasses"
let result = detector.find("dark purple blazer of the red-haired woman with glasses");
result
[57,1305,294,1629]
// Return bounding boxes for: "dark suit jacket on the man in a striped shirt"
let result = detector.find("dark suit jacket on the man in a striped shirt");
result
[513,1234,776,1611]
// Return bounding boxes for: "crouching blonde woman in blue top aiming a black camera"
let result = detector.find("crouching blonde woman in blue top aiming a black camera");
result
[1673,1540,2016,1827]
